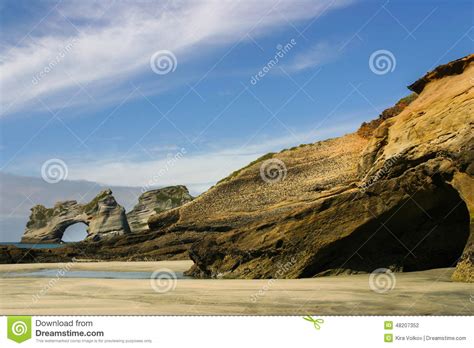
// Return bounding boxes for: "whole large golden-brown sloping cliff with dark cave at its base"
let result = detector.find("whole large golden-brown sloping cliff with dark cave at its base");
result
[175,55,474,281]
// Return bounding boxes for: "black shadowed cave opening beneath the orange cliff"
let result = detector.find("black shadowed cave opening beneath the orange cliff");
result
[300,179,470,277]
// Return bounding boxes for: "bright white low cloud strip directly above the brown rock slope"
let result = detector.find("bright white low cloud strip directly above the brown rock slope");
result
[68,121,360,194]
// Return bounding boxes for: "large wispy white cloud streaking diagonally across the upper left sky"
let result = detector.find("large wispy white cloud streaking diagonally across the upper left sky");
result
[0,0,350,117]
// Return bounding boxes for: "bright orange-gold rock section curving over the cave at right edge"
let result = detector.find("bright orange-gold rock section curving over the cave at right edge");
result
[359,55,474,282]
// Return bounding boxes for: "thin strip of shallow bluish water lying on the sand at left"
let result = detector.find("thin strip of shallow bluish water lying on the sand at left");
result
[0,268,191,281]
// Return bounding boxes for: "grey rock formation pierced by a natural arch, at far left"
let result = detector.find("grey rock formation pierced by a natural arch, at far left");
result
[21,190,130,243]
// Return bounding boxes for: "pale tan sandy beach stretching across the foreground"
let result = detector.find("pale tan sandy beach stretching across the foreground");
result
[0,261,474,315]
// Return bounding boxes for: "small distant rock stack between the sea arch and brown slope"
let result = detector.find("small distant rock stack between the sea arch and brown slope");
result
[127,185,193,232]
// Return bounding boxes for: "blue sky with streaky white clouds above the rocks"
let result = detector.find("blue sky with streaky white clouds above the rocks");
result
[0,0,474,194]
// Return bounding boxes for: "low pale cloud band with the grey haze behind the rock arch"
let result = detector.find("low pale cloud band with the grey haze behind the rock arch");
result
[0,110,369,241]
